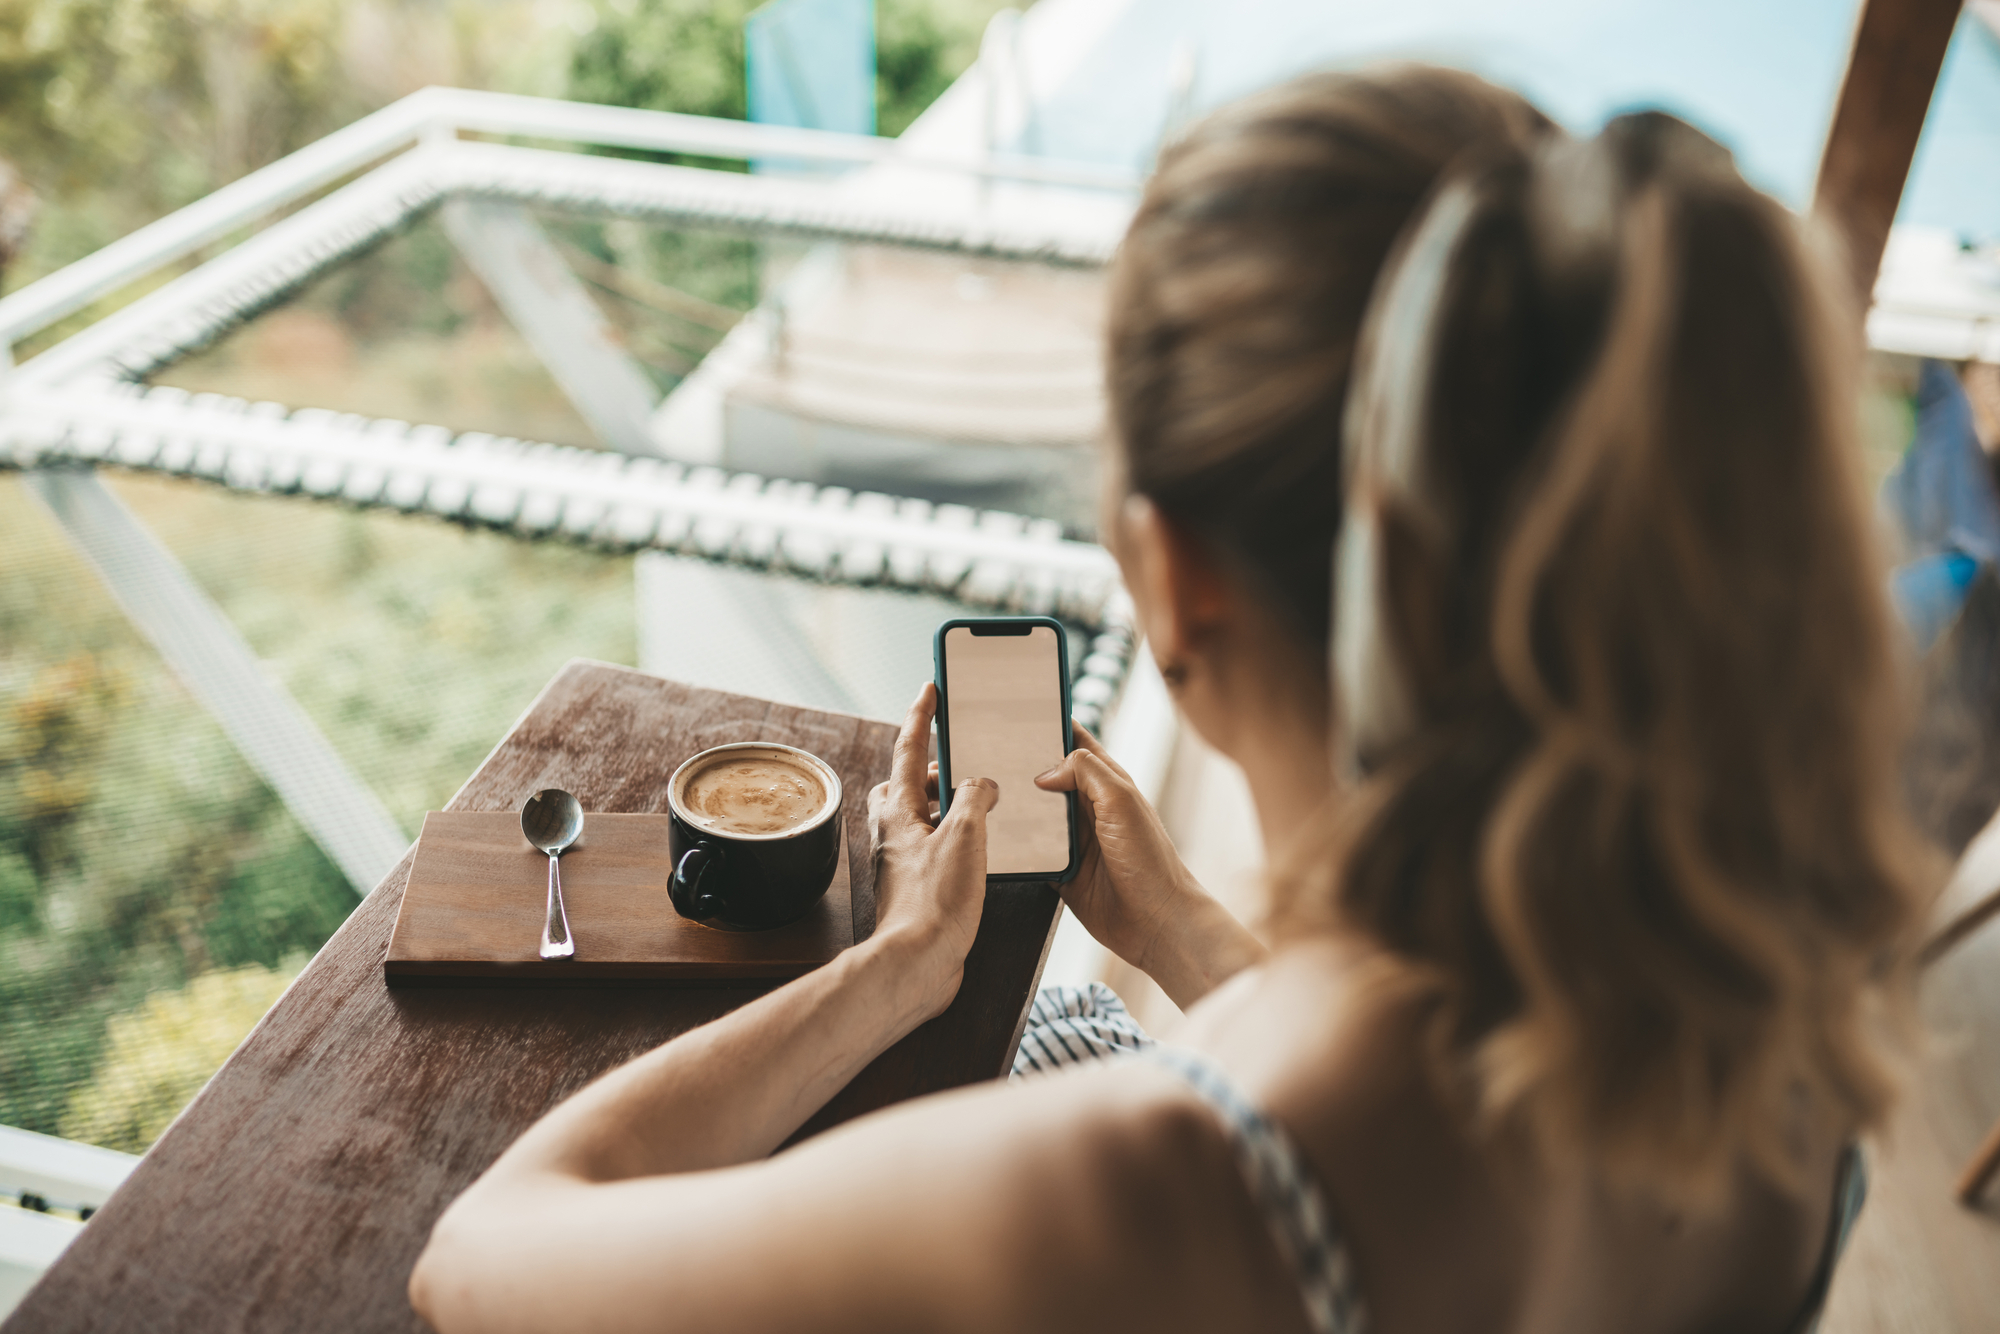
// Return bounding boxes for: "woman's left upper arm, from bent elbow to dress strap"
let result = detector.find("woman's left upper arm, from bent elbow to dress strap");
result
[410,1040,1302,1334]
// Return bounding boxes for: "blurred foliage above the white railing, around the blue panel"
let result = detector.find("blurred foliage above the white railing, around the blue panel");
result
[0,0,1004,286]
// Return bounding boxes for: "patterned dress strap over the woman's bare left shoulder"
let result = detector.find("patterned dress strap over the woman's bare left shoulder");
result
[1146,1046,1368,1334]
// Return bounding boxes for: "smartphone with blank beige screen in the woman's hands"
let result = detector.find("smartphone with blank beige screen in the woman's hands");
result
[932,616,1076,882]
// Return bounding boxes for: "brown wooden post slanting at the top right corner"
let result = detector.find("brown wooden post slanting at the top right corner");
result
[1812,0,1958,306]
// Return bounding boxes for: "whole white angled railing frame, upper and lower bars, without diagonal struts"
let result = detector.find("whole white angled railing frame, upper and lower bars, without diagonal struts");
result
[0,90,1134,624]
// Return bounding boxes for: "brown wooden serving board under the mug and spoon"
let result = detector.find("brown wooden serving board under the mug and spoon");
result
[382,810,854,986]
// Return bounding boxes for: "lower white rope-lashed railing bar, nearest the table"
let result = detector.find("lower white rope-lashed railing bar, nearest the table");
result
[0,384,1120,622]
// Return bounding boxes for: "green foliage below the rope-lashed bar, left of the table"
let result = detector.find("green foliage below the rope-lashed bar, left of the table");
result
[0,478,636,1148]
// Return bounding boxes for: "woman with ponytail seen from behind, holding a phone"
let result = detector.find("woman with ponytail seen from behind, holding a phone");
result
[410,70,1914,1334]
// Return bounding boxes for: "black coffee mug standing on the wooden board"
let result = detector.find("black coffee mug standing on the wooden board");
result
[666,742,840,932]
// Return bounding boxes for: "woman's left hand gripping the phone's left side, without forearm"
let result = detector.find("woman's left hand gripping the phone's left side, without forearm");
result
[868,682,1002,1014]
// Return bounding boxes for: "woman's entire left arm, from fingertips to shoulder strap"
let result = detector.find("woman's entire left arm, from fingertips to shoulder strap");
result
[410,688,1296,1334]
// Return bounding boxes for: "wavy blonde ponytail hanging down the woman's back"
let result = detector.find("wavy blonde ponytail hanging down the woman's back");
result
[1328,114,1930,1206]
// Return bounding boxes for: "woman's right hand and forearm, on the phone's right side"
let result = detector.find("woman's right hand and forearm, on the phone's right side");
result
[1034,724,1266,1008]
